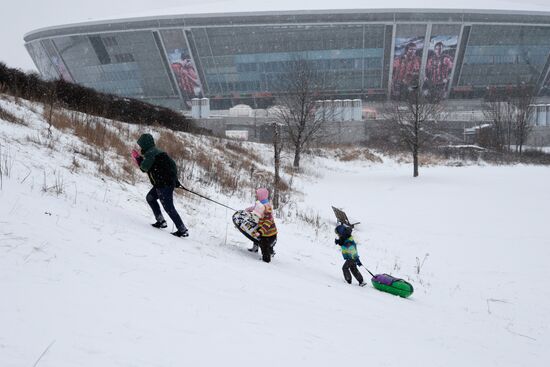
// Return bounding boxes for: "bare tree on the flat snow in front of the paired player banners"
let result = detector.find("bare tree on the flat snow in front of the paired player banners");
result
[383,85,443,177]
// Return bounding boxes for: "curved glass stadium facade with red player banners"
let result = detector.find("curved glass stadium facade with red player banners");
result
[25,10,550,109]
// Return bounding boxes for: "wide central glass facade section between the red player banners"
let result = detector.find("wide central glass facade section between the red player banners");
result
[192,25,385,95]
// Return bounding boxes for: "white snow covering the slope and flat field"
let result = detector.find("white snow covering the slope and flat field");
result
[0,96,550,367]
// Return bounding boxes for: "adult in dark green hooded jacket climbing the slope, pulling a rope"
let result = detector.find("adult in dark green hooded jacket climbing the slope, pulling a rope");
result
[132,134,189,237]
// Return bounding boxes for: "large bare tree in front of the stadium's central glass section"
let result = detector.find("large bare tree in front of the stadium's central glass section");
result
[275,60,331,168]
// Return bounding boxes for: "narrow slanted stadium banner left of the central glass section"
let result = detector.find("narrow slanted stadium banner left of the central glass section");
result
[160,29,202,108]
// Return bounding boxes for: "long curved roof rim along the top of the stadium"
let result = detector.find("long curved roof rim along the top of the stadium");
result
[24,5,550,42]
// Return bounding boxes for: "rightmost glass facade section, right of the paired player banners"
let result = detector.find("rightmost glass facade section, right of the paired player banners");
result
[459,25,550,87]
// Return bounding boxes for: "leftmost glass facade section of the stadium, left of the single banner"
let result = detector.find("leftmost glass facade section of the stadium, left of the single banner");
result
[53,31,176,98]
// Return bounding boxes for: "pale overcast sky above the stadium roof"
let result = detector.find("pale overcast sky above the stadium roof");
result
[0,0,550,70]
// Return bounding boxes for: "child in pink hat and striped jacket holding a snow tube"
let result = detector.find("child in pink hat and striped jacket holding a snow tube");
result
[245,188,277,263]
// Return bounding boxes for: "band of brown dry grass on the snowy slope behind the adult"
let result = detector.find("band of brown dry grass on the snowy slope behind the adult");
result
[34,108,290,200]
